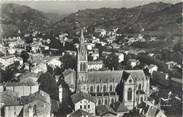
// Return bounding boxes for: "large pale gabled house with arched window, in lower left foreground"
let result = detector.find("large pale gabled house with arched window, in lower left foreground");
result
[21,91,51,117]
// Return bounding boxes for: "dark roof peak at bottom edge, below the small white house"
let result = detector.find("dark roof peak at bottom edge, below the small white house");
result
[67,109,94,117]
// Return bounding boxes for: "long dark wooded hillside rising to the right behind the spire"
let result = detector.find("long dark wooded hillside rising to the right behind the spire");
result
[49,2,182,34]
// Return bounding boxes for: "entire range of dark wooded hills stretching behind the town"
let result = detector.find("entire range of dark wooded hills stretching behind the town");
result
[0,2,183,36]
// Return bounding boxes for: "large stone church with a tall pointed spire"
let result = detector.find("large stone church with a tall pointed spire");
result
[72,30,150,110]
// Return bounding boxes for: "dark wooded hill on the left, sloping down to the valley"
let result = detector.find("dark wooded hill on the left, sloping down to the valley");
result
[1,3,58,36]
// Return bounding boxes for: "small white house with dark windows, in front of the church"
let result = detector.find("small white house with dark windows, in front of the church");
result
[71,92,95,114]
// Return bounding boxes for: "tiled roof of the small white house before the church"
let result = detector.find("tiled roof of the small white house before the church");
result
[71,92,95,103]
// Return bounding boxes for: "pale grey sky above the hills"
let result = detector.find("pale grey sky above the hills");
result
[2,0,182,14]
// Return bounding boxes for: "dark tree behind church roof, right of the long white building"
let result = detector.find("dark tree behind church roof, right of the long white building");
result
[104,52,119,70]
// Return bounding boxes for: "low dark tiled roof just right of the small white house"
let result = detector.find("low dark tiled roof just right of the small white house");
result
[96,105,116,116]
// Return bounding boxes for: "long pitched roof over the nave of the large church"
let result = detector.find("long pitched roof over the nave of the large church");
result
[88,70,146,83]
